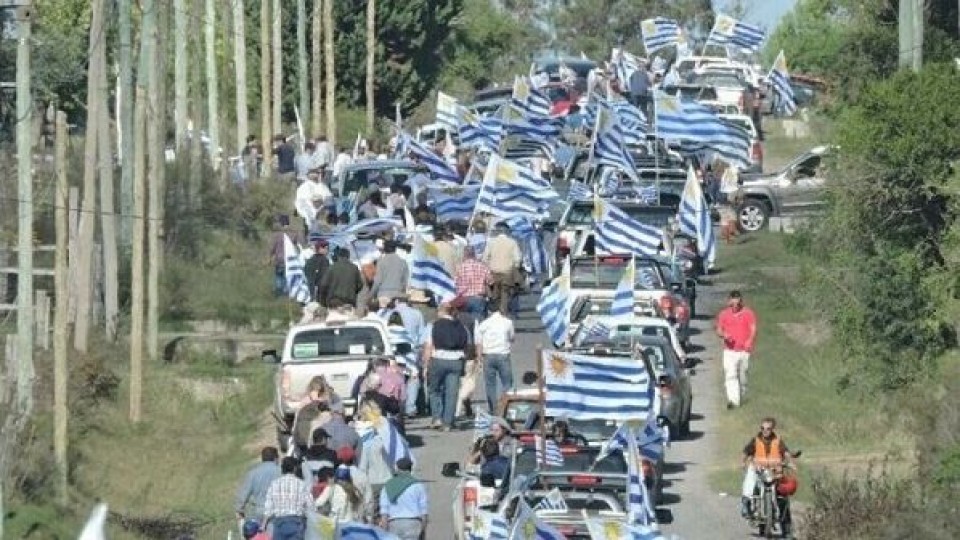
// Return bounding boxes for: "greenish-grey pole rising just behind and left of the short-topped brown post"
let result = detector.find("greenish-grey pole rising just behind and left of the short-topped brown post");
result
[117,0,133,246]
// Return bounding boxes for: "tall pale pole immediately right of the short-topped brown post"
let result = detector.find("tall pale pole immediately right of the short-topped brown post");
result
[143,0,161,368]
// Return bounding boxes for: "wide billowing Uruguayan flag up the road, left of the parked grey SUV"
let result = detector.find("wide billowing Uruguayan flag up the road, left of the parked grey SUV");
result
[654,92,751,169]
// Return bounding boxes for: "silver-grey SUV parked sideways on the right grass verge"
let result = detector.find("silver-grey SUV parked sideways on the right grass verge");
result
[737,146,836,232]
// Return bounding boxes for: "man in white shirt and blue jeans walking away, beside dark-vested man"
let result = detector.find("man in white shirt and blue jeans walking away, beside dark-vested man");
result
[474,305,515,412]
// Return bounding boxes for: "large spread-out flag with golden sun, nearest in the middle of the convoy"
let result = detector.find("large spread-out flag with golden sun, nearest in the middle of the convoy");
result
[541,350,654,422]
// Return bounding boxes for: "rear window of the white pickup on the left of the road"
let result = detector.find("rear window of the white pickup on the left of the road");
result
[290,326,387,361]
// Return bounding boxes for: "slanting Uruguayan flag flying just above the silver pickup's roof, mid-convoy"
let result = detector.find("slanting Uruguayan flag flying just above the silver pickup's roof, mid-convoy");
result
[594,197,662,255]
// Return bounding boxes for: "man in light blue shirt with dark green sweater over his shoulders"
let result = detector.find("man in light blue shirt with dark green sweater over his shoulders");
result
[380,457,429,540]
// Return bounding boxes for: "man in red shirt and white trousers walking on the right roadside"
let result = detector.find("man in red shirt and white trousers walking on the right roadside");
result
[716,291,757,409]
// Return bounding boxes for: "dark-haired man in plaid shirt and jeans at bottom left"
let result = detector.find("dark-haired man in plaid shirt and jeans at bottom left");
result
[263,456,313,540]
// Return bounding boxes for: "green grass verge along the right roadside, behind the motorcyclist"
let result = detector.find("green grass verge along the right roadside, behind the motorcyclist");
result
[711,232,913,501]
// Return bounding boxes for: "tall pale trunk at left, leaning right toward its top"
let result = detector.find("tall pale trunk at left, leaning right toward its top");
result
[73,0,106,352]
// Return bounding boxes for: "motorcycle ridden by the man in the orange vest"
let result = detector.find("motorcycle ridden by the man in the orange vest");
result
[751,452,800,538]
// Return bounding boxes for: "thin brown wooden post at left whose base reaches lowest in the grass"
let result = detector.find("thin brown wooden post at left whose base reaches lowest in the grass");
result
[53,111,69,506]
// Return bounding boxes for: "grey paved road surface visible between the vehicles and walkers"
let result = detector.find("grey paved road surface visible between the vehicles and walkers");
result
[408,287,750,540]
